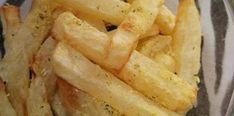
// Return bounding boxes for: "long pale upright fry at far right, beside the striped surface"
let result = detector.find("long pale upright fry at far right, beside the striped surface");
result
[173,0,201,87]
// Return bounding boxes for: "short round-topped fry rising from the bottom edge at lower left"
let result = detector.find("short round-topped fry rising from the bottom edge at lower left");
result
[27,77,53,116]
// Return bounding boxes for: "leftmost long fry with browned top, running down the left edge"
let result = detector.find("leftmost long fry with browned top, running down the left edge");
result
[0,6,29,116]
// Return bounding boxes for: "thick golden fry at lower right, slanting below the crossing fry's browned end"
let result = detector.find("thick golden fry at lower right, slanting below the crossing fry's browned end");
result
[118,51,196,112]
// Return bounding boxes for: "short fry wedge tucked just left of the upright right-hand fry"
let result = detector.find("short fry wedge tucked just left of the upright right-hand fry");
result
[137,35,175,72]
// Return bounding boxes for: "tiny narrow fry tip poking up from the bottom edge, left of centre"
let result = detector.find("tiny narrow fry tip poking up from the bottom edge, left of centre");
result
[51,93,68,116]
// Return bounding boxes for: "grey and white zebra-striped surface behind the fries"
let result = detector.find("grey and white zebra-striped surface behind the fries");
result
[0,0,234,116]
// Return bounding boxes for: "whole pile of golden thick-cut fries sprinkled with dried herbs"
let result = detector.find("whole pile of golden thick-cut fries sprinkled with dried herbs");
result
[0,0,201,116]
